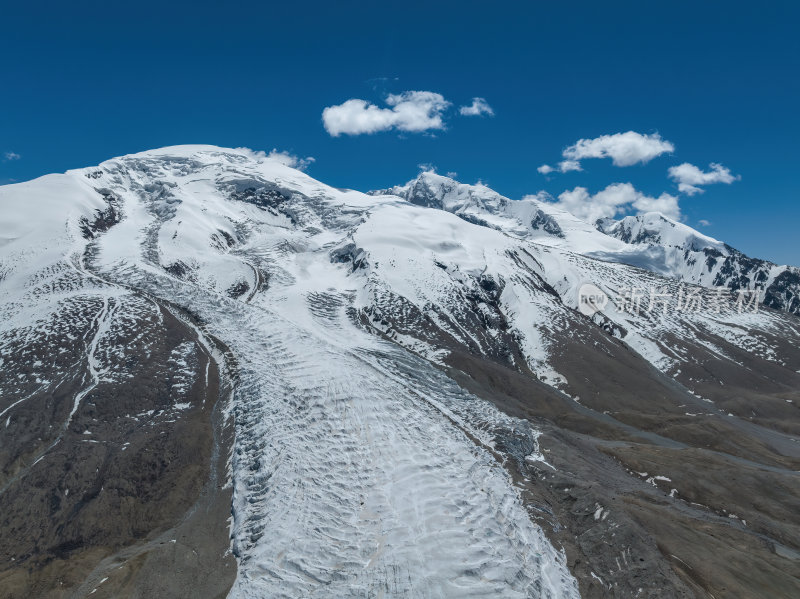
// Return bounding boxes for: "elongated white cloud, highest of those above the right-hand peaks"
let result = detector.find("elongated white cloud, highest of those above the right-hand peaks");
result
[562,131,675,166]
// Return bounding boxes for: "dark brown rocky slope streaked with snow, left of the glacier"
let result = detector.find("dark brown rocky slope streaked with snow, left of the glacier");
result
[0,185,236,598]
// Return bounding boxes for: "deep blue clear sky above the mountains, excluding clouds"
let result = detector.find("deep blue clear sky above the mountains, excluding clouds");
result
[0,1,800,264]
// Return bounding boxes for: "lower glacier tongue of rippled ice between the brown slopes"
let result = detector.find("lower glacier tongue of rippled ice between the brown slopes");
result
[225,313,574,597]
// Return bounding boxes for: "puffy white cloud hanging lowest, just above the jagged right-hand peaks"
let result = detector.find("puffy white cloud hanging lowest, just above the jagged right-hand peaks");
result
[556,183,681,223]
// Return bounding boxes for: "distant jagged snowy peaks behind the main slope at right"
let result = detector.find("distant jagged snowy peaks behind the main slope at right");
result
[376,172,800,314]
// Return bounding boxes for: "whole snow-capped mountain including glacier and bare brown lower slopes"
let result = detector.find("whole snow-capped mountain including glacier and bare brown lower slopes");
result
[0,146,800,597]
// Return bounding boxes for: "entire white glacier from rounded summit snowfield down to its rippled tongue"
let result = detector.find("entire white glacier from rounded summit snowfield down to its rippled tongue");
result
[79,148,578,598]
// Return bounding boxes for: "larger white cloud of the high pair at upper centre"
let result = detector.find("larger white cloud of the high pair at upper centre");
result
[322,91,450,137]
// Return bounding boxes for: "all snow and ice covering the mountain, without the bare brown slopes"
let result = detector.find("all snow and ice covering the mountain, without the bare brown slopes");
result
[0,146,800,597]
